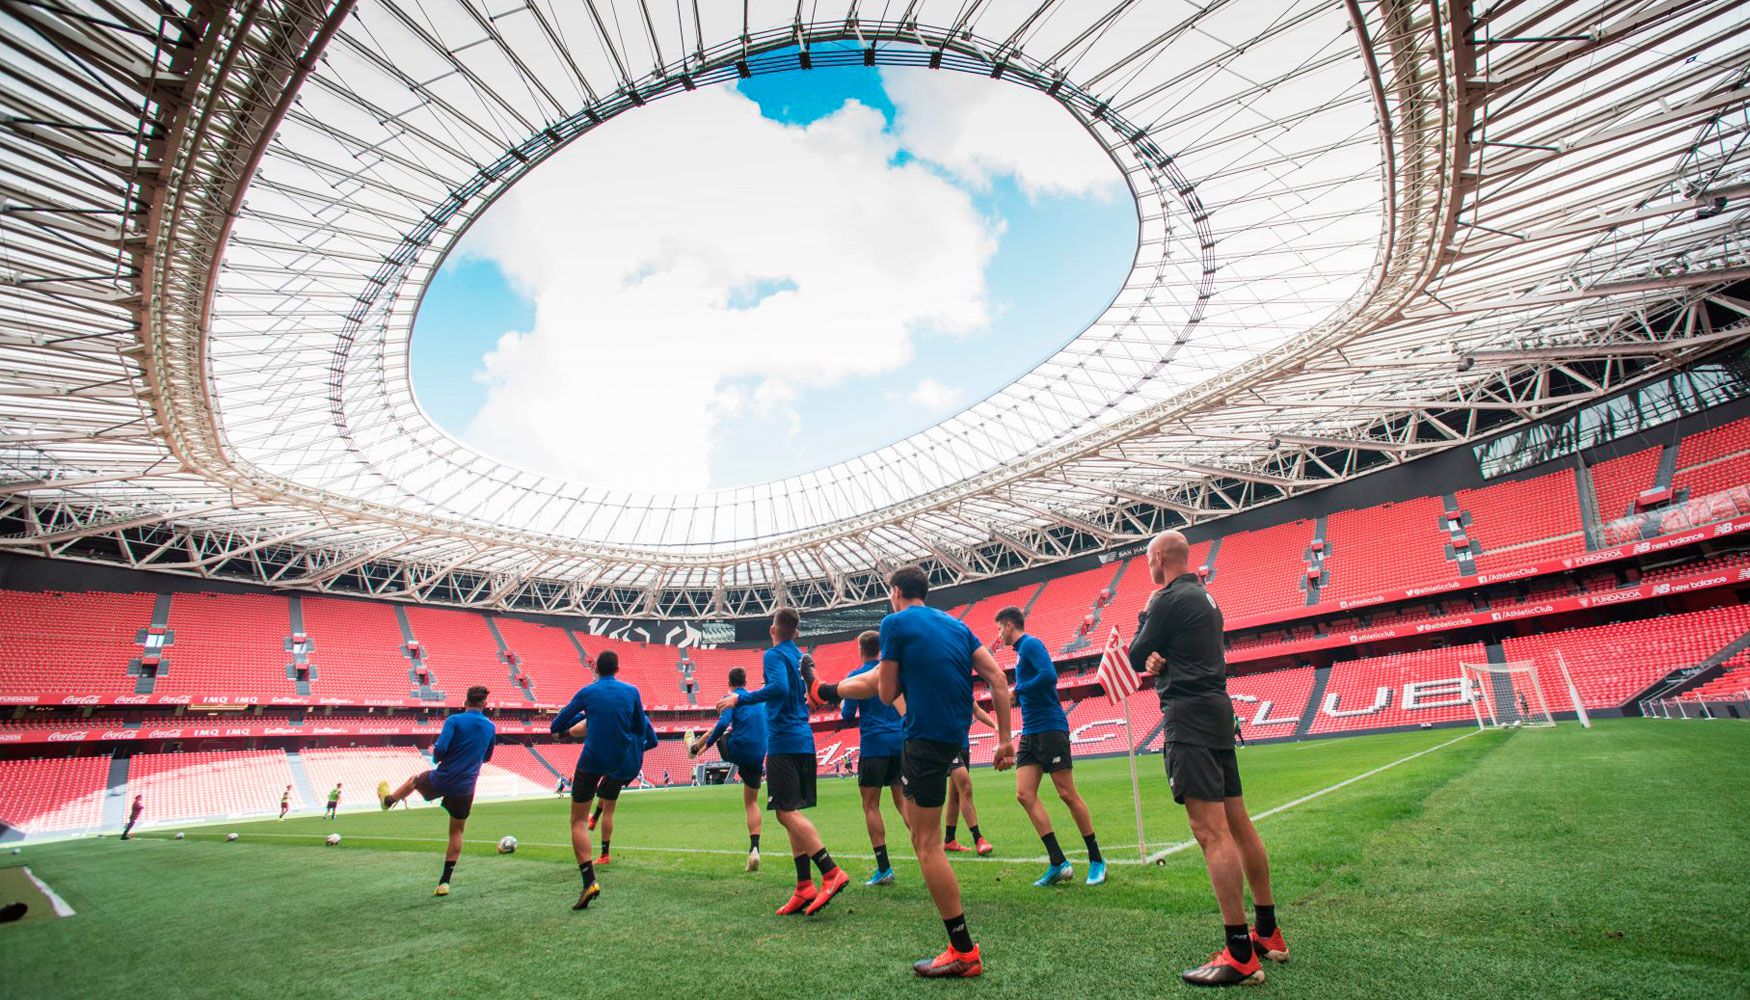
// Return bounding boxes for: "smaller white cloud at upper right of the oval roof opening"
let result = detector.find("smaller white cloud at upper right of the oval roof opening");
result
[882,70,1124,198]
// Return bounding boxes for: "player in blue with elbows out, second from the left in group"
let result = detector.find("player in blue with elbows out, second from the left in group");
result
[548,650,656,909]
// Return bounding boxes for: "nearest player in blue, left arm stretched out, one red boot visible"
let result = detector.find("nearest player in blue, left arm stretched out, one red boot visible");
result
[817,566,1015,979]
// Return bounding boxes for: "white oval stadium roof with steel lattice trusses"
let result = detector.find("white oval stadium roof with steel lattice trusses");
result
[0,0,1750,616]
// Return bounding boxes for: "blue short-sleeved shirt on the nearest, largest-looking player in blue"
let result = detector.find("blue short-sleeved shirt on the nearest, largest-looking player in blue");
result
[880,604,982,746]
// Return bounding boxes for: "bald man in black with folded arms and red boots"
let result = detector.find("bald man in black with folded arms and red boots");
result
[1131,531,1288,986]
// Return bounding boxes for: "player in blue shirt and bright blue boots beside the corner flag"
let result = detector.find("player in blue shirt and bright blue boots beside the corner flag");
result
[996,608,1106,886]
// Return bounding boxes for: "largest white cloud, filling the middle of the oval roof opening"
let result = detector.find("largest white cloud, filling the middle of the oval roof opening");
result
[464,88,999,492]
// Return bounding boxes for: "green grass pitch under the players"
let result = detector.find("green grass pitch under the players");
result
[0,720,1750,1000]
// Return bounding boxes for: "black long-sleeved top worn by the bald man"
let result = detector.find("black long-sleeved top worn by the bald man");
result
[1131,573,1234,750]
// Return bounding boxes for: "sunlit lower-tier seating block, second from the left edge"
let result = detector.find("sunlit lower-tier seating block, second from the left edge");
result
[128,750,301,825]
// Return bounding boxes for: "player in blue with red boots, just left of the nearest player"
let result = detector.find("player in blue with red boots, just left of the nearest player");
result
[718,608,851,916]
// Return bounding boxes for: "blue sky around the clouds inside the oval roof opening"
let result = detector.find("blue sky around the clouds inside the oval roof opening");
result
[411,67,1136,489]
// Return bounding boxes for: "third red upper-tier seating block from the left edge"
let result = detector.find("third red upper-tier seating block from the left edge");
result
[303,597,420,699]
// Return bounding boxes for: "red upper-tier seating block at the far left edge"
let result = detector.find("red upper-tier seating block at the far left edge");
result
[0,590,154,695]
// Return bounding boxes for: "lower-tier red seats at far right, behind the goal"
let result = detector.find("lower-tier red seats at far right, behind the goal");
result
[1502,604,1750,711]
